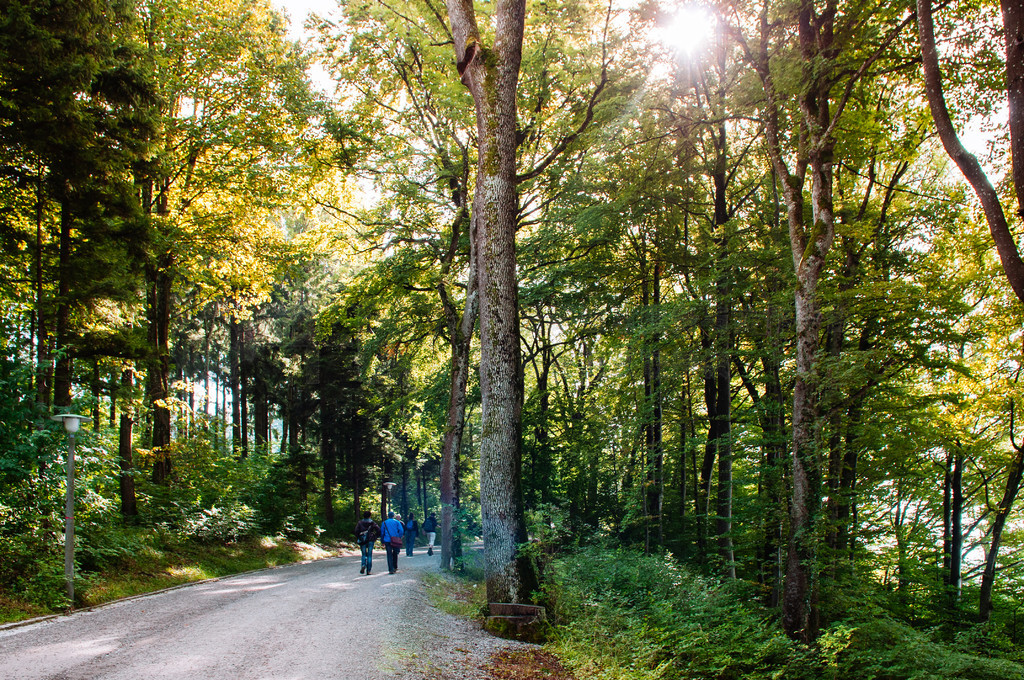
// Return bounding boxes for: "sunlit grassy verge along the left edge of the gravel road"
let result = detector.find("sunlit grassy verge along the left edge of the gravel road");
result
[0,538,344,624]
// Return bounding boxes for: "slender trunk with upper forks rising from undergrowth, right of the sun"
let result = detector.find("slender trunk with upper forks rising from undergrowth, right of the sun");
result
[754,0,872,642]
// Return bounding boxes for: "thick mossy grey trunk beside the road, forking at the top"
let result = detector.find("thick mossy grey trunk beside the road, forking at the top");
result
[445,0,537,602]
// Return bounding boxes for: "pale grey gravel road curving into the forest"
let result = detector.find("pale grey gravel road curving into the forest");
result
[0,550,530,680]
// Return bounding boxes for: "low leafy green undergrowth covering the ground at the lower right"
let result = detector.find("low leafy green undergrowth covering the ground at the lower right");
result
[543,548,1024,680]
